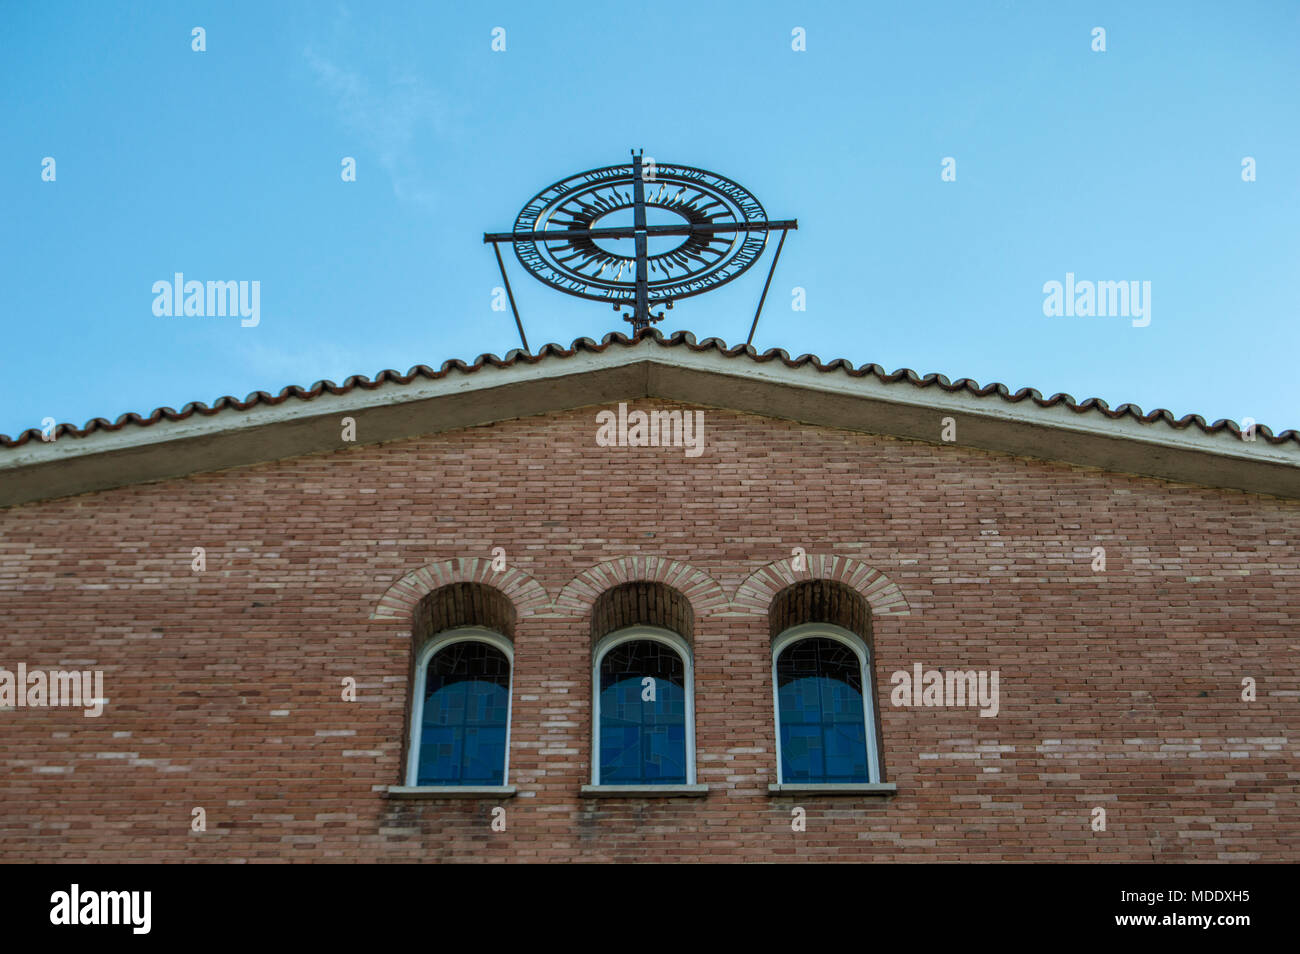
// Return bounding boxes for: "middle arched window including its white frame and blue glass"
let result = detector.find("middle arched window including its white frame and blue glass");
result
[592,626,696,785]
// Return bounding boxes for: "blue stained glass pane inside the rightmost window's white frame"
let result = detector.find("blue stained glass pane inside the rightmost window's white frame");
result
[776,638,870,782]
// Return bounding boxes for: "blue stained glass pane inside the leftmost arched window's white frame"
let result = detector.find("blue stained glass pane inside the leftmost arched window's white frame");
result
[416,642,510,785]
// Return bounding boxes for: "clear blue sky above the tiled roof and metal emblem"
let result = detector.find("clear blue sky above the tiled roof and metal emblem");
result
[0,0,1300,435]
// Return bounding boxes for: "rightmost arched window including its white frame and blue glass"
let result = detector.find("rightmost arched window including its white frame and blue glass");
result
[772,623,880,785]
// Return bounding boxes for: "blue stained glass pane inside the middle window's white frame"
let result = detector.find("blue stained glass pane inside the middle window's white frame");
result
[601,639,686,785]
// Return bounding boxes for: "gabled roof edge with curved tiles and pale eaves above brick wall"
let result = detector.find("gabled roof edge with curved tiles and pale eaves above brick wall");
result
[0,330,1300,507]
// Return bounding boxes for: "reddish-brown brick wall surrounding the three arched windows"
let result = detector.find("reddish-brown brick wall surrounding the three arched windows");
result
[0,402,1300,860]
